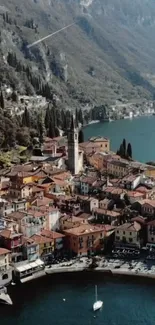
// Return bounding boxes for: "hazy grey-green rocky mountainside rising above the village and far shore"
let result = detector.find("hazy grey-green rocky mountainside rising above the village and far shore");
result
[0,0,155,107]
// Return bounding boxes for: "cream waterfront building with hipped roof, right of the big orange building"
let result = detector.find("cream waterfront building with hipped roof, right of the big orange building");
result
[115,221,141,247]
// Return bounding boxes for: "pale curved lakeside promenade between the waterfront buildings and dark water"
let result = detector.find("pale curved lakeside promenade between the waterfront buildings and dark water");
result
[21,257,155,283]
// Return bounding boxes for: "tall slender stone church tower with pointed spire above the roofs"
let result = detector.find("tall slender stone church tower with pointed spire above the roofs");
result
[68,116,79,174]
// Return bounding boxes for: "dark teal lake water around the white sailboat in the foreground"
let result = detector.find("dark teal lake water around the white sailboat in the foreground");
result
[0,274,155,325]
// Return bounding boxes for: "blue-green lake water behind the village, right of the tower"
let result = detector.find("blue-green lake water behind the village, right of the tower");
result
[84,116,155,162]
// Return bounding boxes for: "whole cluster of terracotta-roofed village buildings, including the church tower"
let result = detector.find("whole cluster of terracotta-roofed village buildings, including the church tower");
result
[0,117,155,285]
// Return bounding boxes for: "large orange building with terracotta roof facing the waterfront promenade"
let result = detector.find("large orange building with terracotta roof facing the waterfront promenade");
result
[64,224,114,256]
